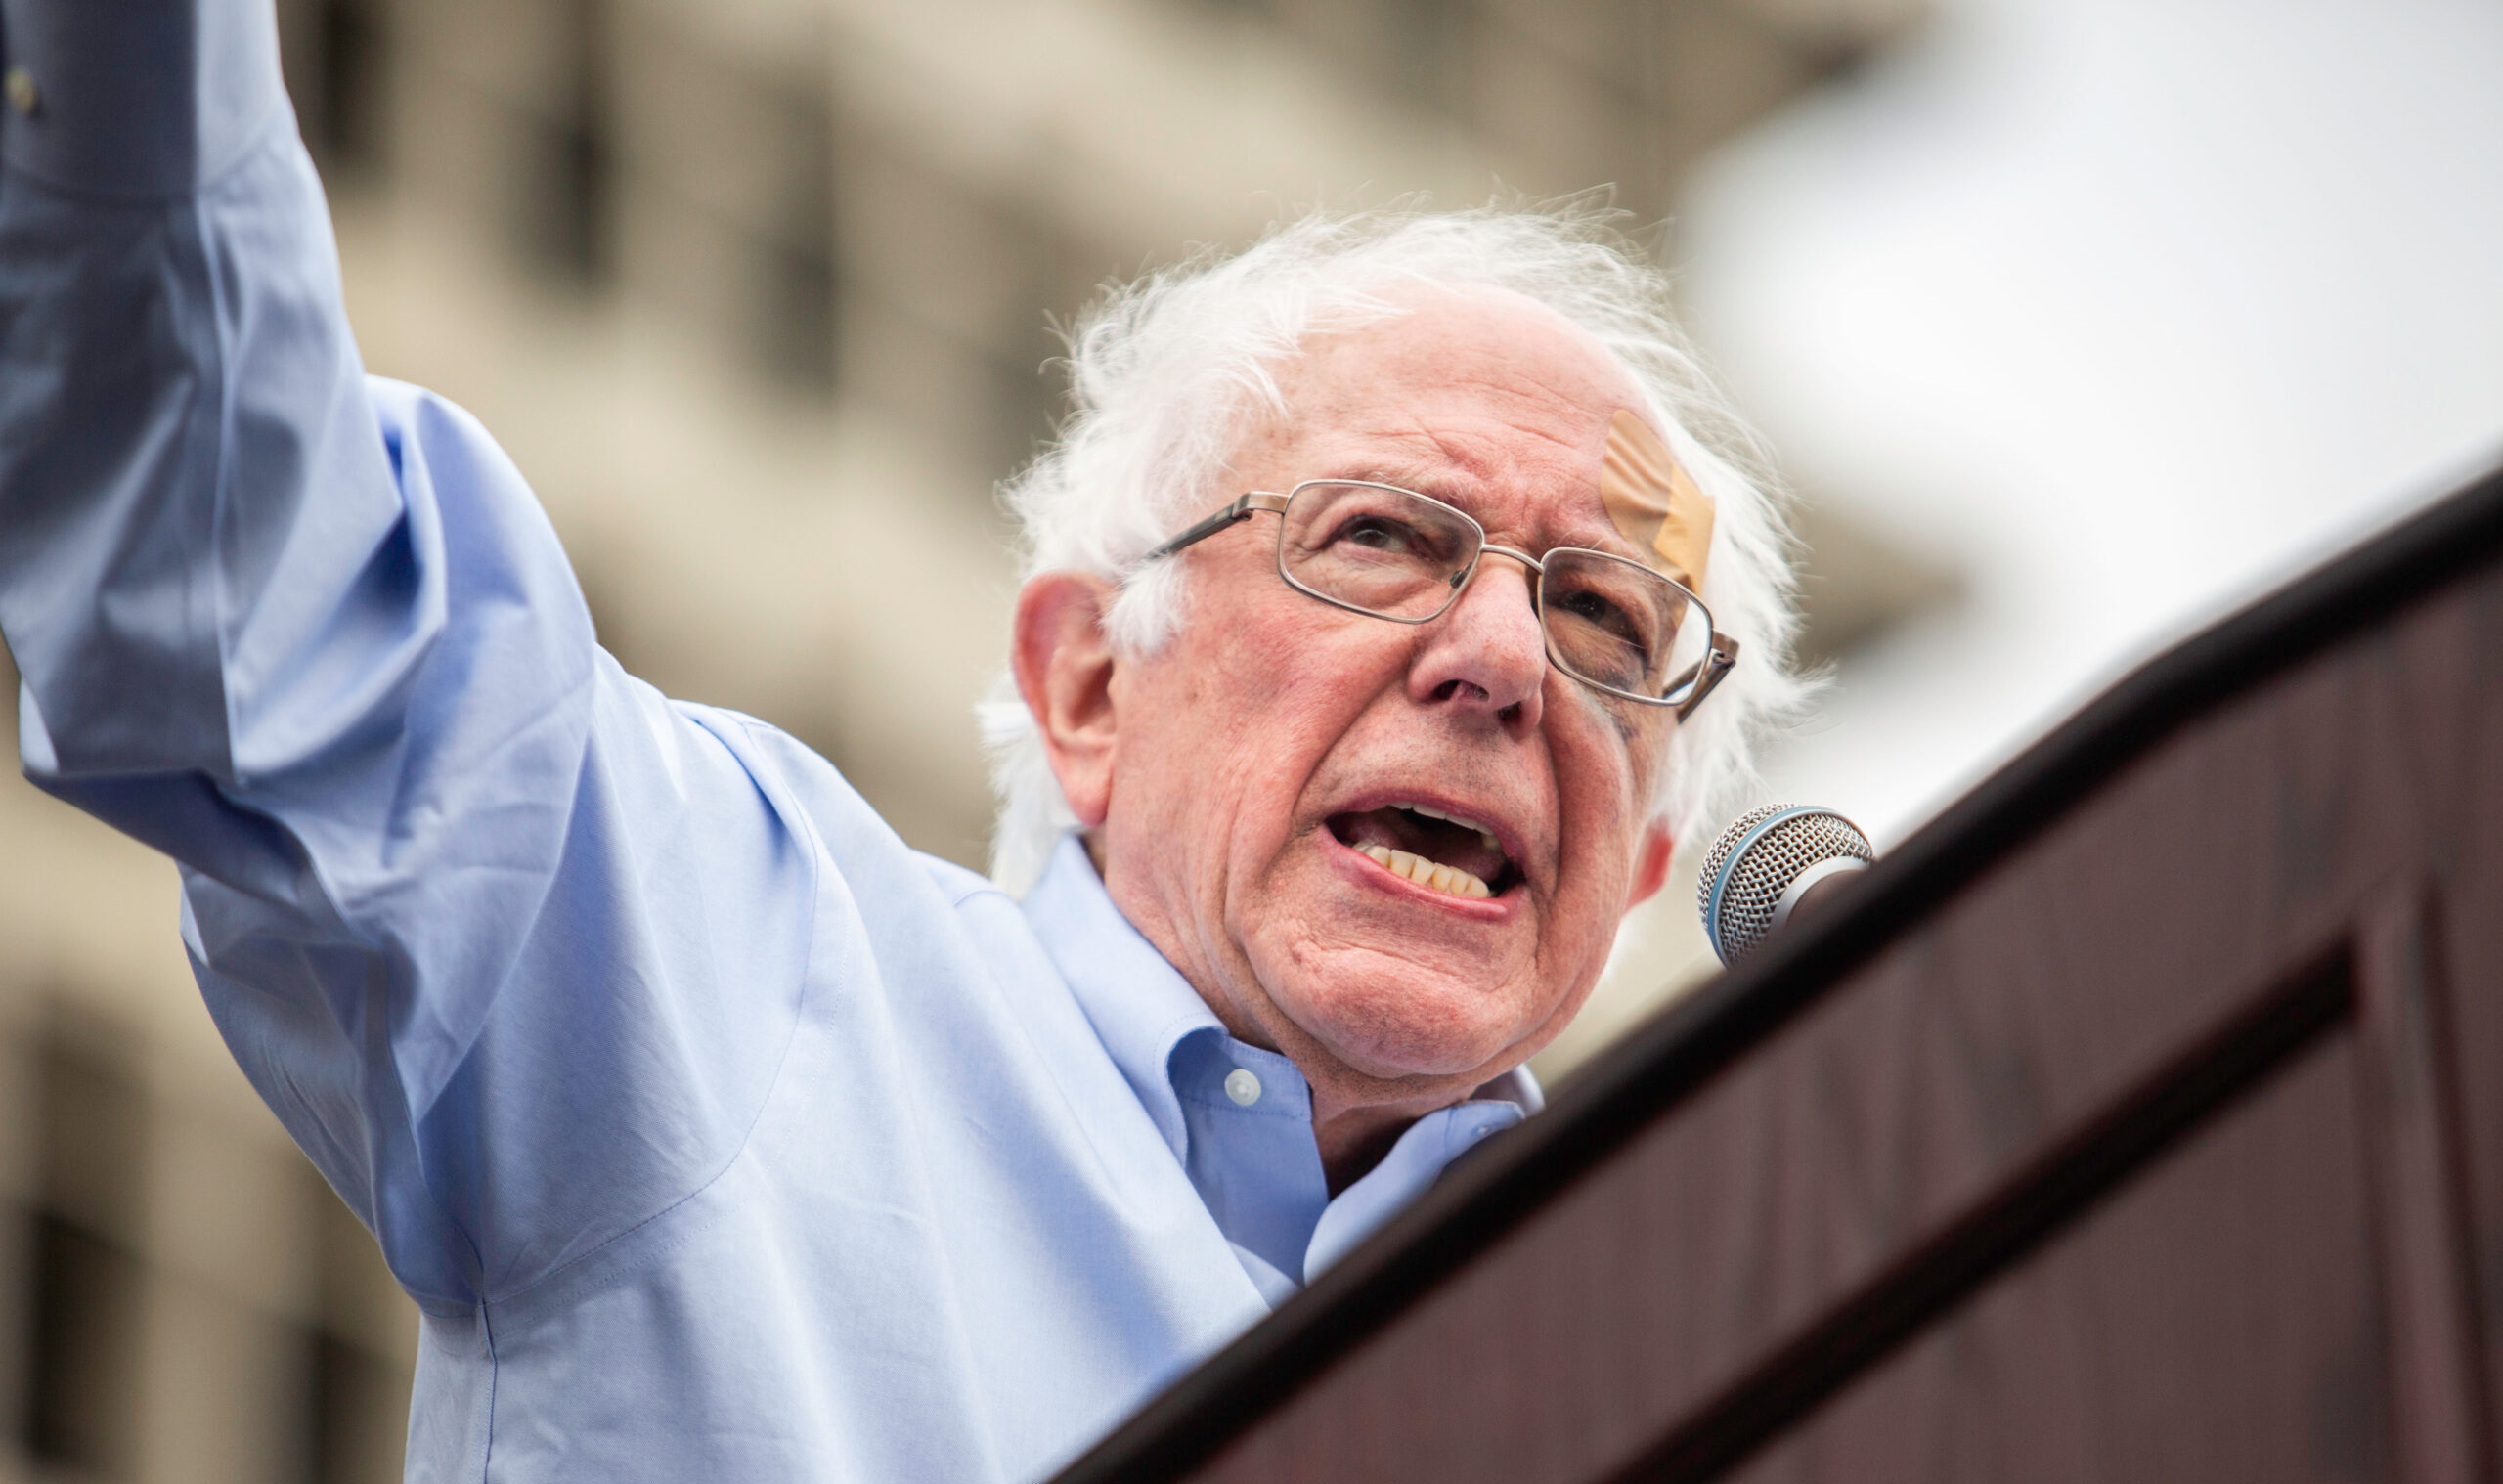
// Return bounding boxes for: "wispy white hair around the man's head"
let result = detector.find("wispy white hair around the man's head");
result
[979,200,1802,891]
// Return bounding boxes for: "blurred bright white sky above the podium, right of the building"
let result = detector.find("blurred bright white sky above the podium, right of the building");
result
[1682,0,2503,839]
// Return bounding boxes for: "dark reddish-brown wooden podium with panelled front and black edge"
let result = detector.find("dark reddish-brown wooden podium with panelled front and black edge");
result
[1064,475,2503,1484]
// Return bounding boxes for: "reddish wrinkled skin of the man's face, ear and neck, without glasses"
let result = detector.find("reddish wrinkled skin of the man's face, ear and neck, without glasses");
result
[1016,290,1675,1189]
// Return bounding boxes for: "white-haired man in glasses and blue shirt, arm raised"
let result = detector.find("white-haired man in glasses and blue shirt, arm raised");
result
[0,0,1784,1481]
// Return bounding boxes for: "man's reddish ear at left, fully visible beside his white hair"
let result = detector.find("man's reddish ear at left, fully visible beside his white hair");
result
[1011,573,1119,828]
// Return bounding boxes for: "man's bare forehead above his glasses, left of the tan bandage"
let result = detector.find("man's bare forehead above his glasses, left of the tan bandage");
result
[1232,290,1642,536]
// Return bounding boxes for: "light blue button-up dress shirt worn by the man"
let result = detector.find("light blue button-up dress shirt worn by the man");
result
[0,0,1537,1481]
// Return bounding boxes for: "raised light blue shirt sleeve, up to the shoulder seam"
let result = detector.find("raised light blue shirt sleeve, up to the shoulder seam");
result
[0,0,821,1309]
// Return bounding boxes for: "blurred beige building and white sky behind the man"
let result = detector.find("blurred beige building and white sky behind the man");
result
[0,0,2503,1481]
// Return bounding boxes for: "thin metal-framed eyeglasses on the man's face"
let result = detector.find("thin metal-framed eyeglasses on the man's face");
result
[1144,480,1737,720]
